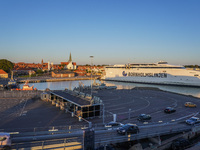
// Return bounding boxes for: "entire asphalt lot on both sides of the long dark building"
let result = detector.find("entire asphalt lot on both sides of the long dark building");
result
[0,88,200,131]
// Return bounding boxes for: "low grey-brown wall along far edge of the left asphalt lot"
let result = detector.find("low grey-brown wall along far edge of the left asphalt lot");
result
[0,90,42,98]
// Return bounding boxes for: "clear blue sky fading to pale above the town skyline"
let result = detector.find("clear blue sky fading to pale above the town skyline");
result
[0,0,200,65]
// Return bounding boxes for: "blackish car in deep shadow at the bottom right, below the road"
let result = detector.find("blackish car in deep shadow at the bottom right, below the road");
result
[171,138,191,150]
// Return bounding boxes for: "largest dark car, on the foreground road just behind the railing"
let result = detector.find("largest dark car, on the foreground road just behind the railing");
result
[117,124,139,135]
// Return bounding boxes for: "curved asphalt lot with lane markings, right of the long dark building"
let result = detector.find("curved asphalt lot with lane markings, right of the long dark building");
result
[91,89,200,124]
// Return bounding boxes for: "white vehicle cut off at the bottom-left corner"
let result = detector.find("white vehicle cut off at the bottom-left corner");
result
[0,133,11,150]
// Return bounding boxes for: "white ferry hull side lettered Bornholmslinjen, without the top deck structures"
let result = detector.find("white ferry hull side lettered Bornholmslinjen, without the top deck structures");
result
[104,68,200,87]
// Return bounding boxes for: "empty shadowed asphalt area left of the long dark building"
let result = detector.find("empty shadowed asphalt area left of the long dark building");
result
[0,98,85,132]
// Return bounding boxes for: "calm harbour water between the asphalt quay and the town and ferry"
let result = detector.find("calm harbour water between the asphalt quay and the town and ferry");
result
[20,80,200,98]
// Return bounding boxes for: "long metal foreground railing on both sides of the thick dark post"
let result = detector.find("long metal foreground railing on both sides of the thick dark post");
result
[9,126,191,149]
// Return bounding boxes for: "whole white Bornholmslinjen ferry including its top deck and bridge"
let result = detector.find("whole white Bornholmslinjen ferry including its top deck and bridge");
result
[102,61,200,87]
